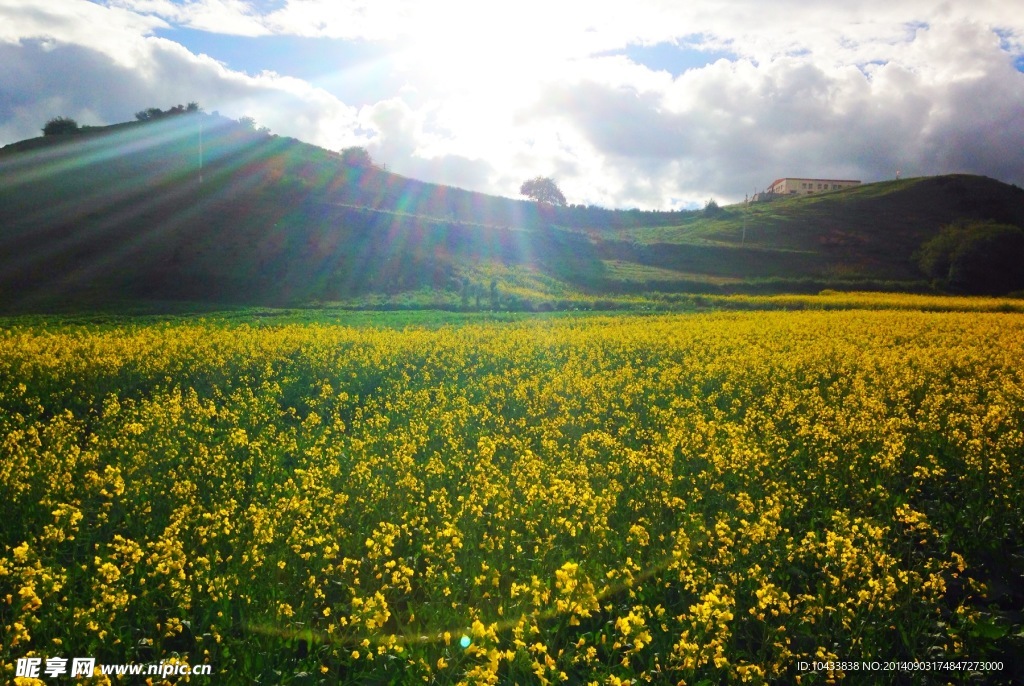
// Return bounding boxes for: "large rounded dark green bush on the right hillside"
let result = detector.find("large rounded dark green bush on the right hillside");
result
[916,221,1024,294]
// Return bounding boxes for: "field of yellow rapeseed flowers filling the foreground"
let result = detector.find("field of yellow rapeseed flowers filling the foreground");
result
[0,310,1024,684]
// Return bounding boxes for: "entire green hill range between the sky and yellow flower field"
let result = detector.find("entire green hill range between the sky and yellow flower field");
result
[0,114,1024,309]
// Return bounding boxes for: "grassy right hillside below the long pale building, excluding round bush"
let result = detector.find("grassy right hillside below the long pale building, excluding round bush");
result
[598,174,1024,290]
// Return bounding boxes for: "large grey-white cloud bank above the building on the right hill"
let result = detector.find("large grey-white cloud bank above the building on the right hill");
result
[505,16,1024,207]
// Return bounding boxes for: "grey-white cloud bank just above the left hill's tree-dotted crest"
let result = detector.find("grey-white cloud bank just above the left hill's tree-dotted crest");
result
[0,0,359,148]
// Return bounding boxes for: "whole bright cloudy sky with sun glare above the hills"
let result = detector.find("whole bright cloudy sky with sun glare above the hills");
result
[0,0,1024,210]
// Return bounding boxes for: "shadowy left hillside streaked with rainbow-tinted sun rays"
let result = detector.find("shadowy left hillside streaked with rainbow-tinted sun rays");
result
[0,116,600,301]
